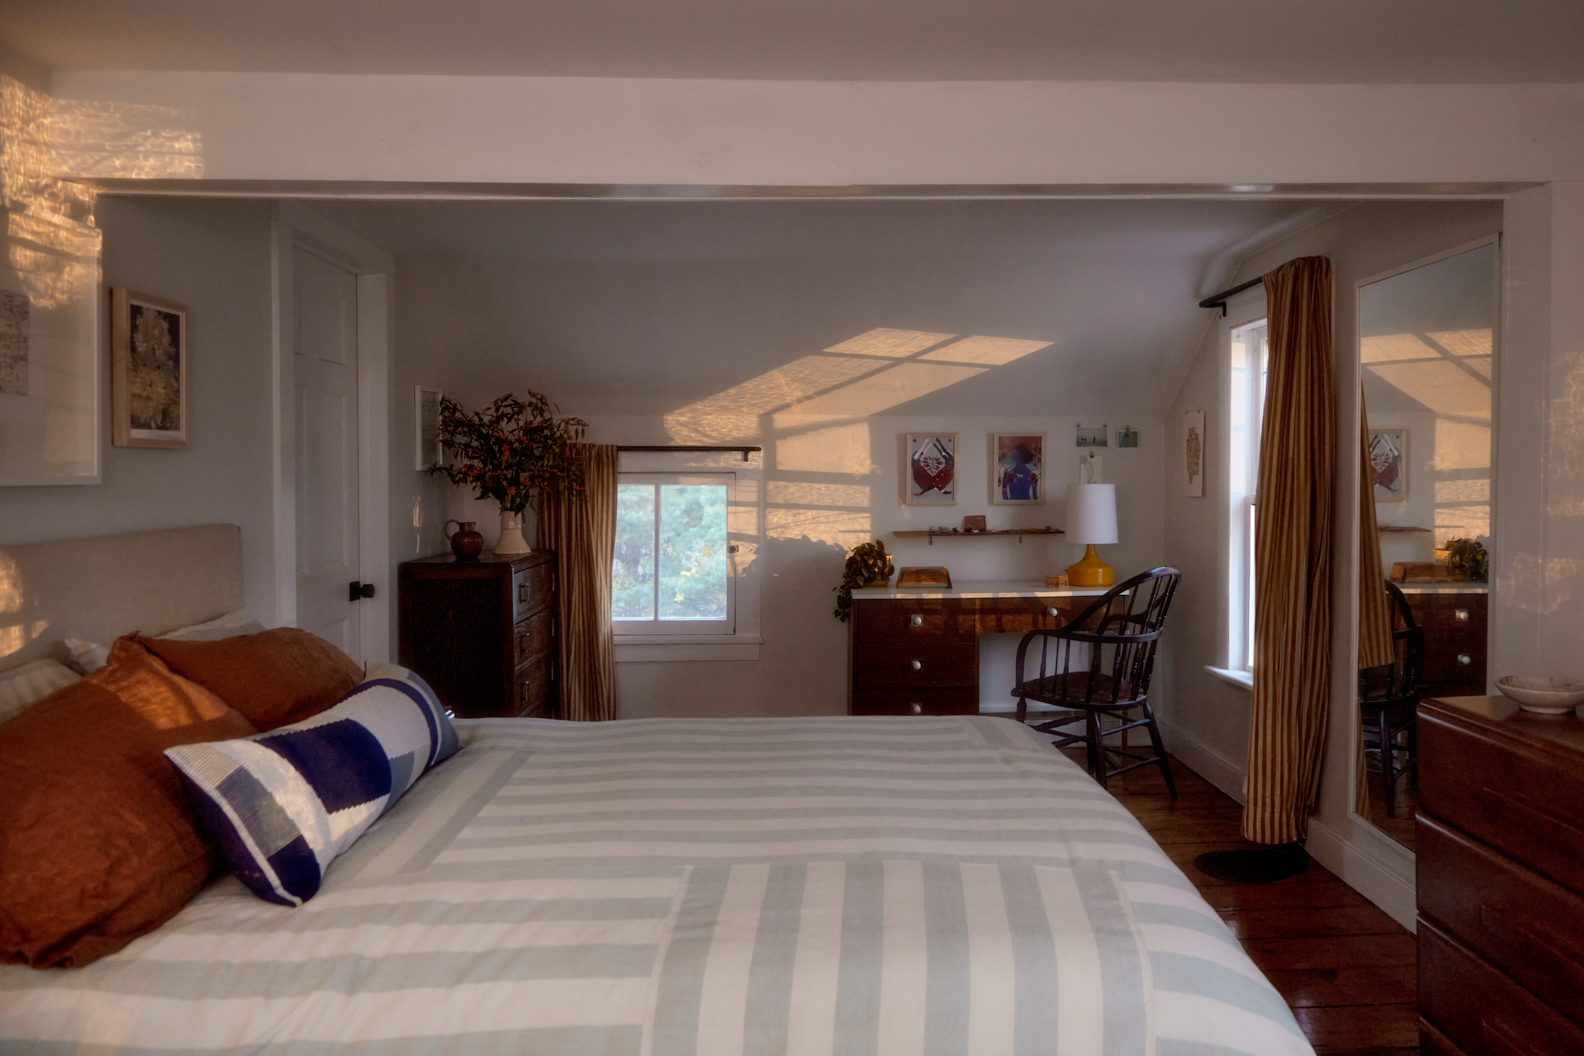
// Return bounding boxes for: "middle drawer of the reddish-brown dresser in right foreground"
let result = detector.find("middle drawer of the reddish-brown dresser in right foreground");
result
[1415,814,1584,1023]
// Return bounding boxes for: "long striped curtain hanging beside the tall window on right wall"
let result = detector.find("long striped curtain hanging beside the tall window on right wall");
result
[1243,256,1337,844]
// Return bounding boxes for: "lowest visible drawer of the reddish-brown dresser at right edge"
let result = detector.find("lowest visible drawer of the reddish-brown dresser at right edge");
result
[1419,917,1584,1056]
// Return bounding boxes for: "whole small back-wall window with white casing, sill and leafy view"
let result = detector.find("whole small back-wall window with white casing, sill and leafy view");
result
[610,451,763,663]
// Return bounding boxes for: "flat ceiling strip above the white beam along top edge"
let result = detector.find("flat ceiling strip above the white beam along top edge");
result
[0,0,1584,84]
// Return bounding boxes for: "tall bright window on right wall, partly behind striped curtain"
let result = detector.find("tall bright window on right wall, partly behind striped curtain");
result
[1226,320,1269,674]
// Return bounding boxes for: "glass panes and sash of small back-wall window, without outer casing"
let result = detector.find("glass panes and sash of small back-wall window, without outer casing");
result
[610,473,737,635]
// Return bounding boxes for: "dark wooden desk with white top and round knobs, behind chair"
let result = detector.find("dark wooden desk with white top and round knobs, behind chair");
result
[847,579,1110,716]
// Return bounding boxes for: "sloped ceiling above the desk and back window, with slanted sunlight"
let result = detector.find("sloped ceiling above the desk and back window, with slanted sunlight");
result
[314,201,1330,418]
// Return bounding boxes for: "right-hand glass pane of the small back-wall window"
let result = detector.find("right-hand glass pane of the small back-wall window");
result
[659,484,729,619]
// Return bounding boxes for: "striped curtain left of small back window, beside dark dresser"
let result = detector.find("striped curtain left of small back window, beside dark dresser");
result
[537,443,616,722]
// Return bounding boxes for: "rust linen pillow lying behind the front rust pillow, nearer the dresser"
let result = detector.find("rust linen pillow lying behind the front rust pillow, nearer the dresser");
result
[138,627,363,731]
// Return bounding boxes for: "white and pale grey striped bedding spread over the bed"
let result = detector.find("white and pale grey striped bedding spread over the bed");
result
[0,716,1312,1056]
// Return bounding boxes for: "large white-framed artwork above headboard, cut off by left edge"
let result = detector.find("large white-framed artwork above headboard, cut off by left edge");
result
[0,207,105,486]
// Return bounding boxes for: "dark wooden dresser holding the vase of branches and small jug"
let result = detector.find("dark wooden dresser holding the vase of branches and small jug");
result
[398,549,556,719]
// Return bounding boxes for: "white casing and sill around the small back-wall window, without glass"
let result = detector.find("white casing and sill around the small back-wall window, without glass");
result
[611,451,763,663]
